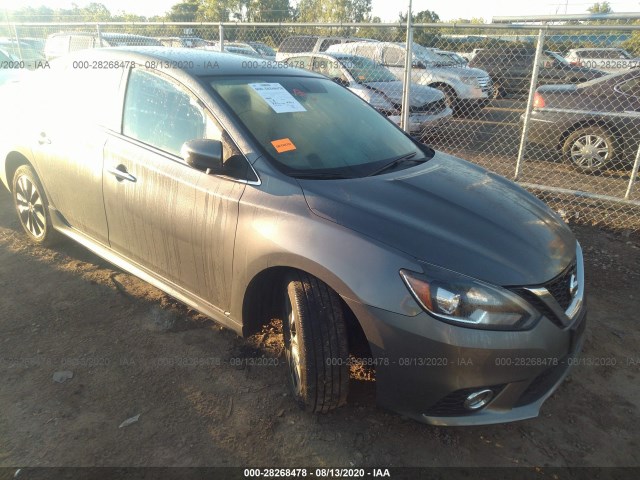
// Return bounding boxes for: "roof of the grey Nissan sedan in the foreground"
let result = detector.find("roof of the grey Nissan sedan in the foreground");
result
[66,46,325,78]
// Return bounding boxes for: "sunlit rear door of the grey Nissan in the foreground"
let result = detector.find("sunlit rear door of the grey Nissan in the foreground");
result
[33,63,123,245]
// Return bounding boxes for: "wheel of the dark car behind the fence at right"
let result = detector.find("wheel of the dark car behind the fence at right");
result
[562,125,617,174]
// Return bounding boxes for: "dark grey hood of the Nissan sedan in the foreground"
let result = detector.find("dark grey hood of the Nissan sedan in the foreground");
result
[299,152,576,286]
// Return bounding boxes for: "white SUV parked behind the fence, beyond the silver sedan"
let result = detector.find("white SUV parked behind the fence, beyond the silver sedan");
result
[327,42,493,114]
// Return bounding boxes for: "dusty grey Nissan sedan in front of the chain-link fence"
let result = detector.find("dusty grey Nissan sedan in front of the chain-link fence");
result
[0,47,586,425]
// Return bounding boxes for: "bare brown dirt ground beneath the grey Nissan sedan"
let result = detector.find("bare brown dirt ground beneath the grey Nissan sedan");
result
[0,186,640,467]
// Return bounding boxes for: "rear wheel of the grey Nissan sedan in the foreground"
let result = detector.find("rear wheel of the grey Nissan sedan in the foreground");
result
[11,165,59,246]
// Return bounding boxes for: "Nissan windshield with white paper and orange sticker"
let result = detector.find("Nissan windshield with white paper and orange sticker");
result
[206,76,425,177]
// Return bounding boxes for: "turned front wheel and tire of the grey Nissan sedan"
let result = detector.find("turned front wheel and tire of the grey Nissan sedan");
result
[282,272,349,413]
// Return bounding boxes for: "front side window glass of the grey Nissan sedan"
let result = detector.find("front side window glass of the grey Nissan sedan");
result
[123,68,211,156]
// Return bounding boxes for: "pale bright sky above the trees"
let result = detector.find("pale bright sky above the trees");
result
[0,0,640,22]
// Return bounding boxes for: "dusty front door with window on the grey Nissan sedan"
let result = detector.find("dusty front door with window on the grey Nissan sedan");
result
[104,68,246,308]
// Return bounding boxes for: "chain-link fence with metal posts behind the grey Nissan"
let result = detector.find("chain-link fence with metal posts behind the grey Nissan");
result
[0,15,640,231]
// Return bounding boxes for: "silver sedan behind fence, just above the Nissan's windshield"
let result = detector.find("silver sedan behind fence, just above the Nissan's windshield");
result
[285,53,453,135]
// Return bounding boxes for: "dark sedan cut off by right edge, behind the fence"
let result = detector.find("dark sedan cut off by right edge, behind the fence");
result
[528,69,640,173]
